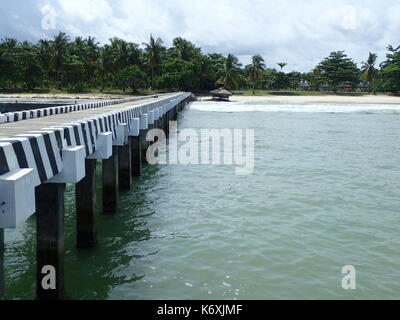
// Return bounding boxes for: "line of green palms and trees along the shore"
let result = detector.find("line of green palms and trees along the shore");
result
[0,32,400,93]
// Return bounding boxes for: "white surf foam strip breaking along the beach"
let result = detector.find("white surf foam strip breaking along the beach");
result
[191,101,400,114]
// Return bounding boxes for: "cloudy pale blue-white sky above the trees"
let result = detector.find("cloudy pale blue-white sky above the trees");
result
[0,0,400,71]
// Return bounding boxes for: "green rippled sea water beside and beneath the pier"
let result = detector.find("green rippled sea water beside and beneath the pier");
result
[5,102,400,299]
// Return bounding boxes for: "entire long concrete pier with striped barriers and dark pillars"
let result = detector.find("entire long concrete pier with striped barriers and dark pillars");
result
[0,93,192,299]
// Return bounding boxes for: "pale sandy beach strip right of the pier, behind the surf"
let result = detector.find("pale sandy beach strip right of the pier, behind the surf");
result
[197,95,400,104]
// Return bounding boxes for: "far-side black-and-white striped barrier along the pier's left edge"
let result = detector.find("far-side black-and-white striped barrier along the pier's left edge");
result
[0,94,172,124]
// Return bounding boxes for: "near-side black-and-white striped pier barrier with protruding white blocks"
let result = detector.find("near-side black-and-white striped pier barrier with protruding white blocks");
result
[0,93,191,229]
